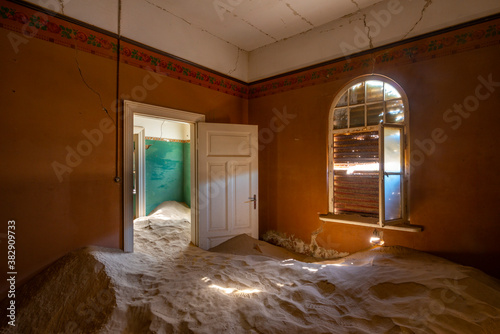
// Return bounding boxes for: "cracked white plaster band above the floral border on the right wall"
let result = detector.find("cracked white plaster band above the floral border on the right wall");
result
[249,0,500,82]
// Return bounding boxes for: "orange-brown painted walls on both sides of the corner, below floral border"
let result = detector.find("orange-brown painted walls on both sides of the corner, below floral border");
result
[0,1,500,297]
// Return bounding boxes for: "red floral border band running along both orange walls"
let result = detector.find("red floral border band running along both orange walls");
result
[0,0,500,99]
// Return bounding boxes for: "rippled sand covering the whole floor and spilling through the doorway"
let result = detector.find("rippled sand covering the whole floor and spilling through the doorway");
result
[3,203,500,334]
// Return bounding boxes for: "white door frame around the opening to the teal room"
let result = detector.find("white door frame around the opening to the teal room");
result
[123,100,205,252]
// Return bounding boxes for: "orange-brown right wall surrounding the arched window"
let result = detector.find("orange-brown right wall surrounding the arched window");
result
[249,45,500,277]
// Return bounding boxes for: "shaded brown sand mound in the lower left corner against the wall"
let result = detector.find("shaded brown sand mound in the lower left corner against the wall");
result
[1,248,116,333]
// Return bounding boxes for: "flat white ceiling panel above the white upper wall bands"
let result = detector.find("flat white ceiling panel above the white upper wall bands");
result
[145,0,382,51]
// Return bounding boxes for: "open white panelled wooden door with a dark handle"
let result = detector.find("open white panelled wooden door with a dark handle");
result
[198,123,259,249]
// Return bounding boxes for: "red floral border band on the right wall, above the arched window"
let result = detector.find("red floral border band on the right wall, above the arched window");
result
[249,19,500,98]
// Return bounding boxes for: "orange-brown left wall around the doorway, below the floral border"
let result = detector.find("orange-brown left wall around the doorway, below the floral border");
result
[0,29,248,299]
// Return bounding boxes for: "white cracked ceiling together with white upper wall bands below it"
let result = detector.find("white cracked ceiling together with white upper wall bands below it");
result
[28,0,500,82]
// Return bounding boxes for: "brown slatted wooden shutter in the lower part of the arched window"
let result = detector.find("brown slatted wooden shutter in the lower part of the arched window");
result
[333,131,379,217]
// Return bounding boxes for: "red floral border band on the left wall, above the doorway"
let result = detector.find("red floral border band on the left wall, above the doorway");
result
[0,0,248,98]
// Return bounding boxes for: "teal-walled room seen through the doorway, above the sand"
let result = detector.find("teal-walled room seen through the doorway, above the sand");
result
[133,113,191,219]
